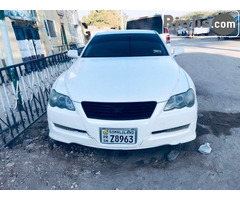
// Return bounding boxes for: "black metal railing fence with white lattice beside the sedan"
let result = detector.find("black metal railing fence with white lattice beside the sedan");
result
[0,52,73,148]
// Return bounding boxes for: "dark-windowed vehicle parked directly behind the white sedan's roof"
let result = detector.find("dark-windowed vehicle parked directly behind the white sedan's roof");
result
[126,15,170,44]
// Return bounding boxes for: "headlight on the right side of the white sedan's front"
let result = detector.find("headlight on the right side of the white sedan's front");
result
[164,88,195,111]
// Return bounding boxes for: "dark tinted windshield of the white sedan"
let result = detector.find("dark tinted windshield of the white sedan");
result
[82,33,168,57]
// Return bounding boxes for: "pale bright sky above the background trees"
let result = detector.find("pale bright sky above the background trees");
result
[78,10,193,20]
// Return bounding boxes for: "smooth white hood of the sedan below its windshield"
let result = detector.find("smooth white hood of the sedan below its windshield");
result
[59,56,188,102]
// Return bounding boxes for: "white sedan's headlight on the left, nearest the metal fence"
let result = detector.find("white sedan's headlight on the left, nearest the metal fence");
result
[49,89,75,111]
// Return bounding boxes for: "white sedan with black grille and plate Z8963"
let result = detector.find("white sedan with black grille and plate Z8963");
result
[47,30,197,149]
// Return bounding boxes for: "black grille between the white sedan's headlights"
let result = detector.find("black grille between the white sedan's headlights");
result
[82,101,157,120]
